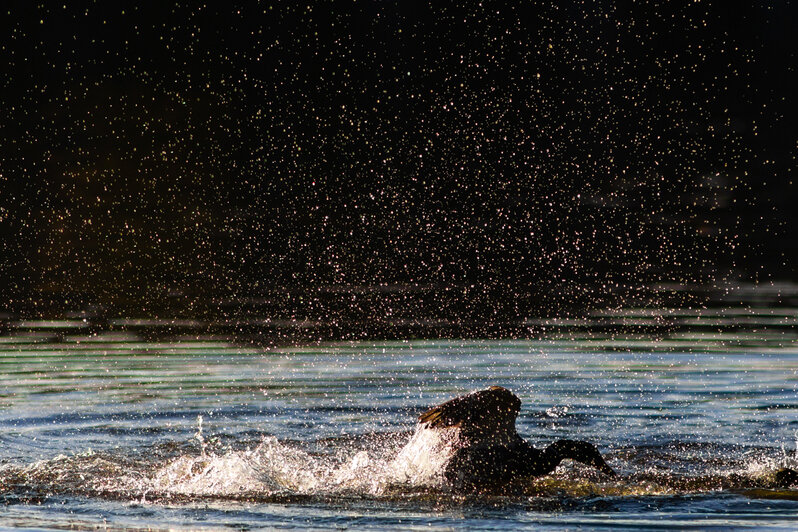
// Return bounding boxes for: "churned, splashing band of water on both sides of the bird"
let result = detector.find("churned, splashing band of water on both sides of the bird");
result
[0,419,798,503]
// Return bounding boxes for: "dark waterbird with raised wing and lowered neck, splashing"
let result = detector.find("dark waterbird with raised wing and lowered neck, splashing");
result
[418,386,616,493]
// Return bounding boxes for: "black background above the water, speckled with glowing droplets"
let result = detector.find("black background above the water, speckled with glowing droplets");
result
[0,0,798,321]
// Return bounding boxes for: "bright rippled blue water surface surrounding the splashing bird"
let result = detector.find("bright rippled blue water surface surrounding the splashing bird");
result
[0,330,798,530]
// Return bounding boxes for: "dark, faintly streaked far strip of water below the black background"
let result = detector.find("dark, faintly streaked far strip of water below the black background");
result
[6,290,798,352]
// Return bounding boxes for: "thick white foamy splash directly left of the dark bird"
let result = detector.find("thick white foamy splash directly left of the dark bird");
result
[146,427,466,496]
